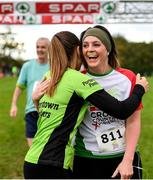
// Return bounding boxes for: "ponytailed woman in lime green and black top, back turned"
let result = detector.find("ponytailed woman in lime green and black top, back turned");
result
[24,31,148,179]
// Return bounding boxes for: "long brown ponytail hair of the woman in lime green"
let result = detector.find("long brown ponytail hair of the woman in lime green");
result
[47,31,81,96]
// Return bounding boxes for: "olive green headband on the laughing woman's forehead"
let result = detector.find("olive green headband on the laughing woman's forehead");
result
[82,28,112,52]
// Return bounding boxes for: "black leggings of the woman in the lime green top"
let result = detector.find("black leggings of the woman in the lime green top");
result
[24,162,72,179]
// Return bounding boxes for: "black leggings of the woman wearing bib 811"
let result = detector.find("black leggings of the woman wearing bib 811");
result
[73,152,142,179]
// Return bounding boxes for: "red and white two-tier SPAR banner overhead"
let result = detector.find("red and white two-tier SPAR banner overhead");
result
[0,1,115,24]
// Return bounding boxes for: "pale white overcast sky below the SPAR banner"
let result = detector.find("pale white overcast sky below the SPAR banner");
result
[0,24,153,59]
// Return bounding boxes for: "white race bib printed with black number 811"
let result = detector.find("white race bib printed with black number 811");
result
[96,127,125,152]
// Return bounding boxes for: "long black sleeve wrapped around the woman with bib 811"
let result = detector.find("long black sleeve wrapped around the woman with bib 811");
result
[86,84,145,119]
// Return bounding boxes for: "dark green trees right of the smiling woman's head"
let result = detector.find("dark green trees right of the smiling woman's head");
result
[114,36,153,76]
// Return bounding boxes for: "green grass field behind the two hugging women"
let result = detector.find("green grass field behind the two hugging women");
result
[0,77,153,179]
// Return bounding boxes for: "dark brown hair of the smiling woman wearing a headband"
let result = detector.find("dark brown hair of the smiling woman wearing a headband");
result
[80,25,120,69]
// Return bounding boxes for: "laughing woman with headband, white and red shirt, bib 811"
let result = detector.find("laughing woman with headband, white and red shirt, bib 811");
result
[73,26,145,179]
